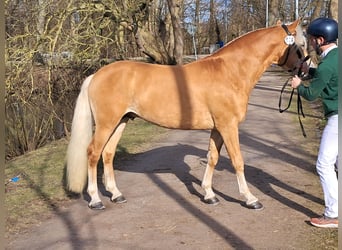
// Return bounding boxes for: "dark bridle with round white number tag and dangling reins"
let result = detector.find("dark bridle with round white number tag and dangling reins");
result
[278,24,310,137]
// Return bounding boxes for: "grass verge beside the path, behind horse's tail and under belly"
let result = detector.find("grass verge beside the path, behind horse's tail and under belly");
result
[5,119,167,238]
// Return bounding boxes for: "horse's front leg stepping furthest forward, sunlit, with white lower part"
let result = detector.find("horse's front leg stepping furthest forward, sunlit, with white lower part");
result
[220,124,263,209]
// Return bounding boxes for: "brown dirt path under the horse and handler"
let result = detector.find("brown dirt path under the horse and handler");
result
[7,69,337,249]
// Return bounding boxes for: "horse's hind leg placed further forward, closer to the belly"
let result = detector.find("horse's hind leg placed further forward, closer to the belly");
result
[102,118,128,203]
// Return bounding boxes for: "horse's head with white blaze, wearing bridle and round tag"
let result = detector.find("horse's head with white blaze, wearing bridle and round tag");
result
[277,19,308,74]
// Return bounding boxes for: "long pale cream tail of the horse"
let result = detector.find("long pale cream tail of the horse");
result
[66,75,93,193]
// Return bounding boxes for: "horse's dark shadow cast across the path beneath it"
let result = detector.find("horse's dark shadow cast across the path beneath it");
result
[84,140,323,217]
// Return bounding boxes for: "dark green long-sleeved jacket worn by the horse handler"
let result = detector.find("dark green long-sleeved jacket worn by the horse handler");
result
[298,48,338,117]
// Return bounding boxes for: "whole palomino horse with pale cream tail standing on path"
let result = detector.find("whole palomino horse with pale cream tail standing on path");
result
[67,20,305,209]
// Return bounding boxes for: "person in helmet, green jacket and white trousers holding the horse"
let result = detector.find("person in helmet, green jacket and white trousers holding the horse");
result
[291,18,338,228]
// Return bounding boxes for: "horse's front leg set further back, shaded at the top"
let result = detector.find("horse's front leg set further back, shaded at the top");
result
[202,129,223,204]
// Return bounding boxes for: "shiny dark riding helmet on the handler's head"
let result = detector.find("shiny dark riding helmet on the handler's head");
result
[307,17,338,44]
